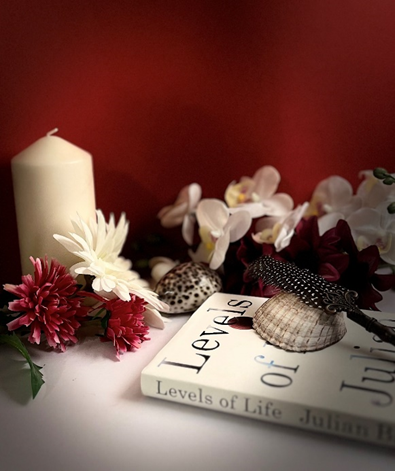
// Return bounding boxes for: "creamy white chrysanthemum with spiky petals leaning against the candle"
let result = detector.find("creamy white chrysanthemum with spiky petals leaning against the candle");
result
[54,210,169,324]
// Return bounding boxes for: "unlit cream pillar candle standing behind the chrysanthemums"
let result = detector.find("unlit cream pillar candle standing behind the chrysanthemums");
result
[11,129,95,274]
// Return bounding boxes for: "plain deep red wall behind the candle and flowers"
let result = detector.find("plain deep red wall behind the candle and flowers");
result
[0,0,395,283]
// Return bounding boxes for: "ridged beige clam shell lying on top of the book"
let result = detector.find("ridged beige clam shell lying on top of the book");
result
[253,291,347,352]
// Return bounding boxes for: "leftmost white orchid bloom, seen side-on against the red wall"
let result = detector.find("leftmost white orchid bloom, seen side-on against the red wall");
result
[158,183,202,245]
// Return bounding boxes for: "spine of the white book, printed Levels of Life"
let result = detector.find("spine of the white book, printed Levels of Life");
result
[141,372,395,448]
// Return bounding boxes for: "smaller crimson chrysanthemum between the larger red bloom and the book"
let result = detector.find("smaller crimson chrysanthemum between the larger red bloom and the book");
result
[101,295,150,360]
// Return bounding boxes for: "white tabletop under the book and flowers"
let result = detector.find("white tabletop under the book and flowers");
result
[0,294,395,471]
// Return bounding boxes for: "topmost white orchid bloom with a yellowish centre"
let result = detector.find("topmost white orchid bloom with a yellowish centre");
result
[225,165,294,218]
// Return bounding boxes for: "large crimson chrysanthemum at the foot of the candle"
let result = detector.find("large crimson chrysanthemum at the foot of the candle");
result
[4,257,88,352]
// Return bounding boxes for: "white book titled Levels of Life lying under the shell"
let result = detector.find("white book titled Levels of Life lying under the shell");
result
[141,293,395,448]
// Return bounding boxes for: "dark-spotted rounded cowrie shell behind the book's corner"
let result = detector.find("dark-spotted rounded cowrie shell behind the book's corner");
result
[155,262,222,314]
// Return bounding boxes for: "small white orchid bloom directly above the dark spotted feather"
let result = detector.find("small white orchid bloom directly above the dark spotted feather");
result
[252,202,309,252]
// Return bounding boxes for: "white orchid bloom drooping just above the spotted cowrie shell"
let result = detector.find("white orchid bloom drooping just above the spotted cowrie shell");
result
[190,199,251,270]
